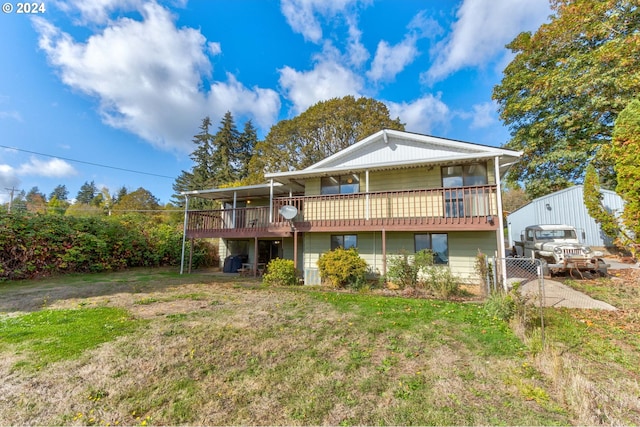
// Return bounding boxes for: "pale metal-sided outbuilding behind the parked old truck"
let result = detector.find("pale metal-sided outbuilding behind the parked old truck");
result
[507,185,624,247]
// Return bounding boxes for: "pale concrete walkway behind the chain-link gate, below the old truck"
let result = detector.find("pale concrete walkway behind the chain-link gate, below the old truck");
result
[520,279,617,310]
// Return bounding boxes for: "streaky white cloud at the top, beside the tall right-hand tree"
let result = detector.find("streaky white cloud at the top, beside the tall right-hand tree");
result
[422,0,551,83]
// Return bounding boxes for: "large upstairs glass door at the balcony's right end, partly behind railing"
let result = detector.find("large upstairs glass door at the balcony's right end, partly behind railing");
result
[442,163,487,218]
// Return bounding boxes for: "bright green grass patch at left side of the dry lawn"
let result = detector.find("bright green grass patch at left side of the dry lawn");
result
[0,307,139,369]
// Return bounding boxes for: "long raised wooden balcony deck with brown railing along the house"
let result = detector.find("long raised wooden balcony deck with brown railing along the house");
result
[187,185,498,238]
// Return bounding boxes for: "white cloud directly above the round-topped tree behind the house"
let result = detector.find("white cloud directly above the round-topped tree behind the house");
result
[279,54,363,114]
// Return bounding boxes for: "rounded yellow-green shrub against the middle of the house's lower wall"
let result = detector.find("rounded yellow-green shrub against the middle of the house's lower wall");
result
[318,248,367,288]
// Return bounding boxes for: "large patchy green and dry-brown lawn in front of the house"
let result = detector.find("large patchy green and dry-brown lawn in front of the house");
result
[0,270,640,425]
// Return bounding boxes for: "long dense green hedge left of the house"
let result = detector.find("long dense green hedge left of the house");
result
[0,212,205,280]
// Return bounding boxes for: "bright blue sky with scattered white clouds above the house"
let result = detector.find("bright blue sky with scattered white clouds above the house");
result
[0,0,551,203]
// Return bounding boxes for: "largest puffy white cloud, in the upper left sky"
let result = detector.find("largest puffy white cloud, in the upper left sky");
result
[33,0,280,152]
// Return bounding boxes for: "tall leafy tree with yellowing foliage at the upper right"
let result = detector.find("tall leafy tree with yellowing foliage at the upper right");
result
[493,0,640,197]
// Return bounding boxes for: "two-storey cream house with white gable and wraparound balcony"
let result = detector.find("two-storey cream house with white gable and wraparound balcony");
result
[183,130,521,284]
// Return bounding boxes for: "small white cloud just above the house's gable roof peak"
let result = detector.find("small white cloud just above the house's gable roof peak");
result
[384,94,451,134]
